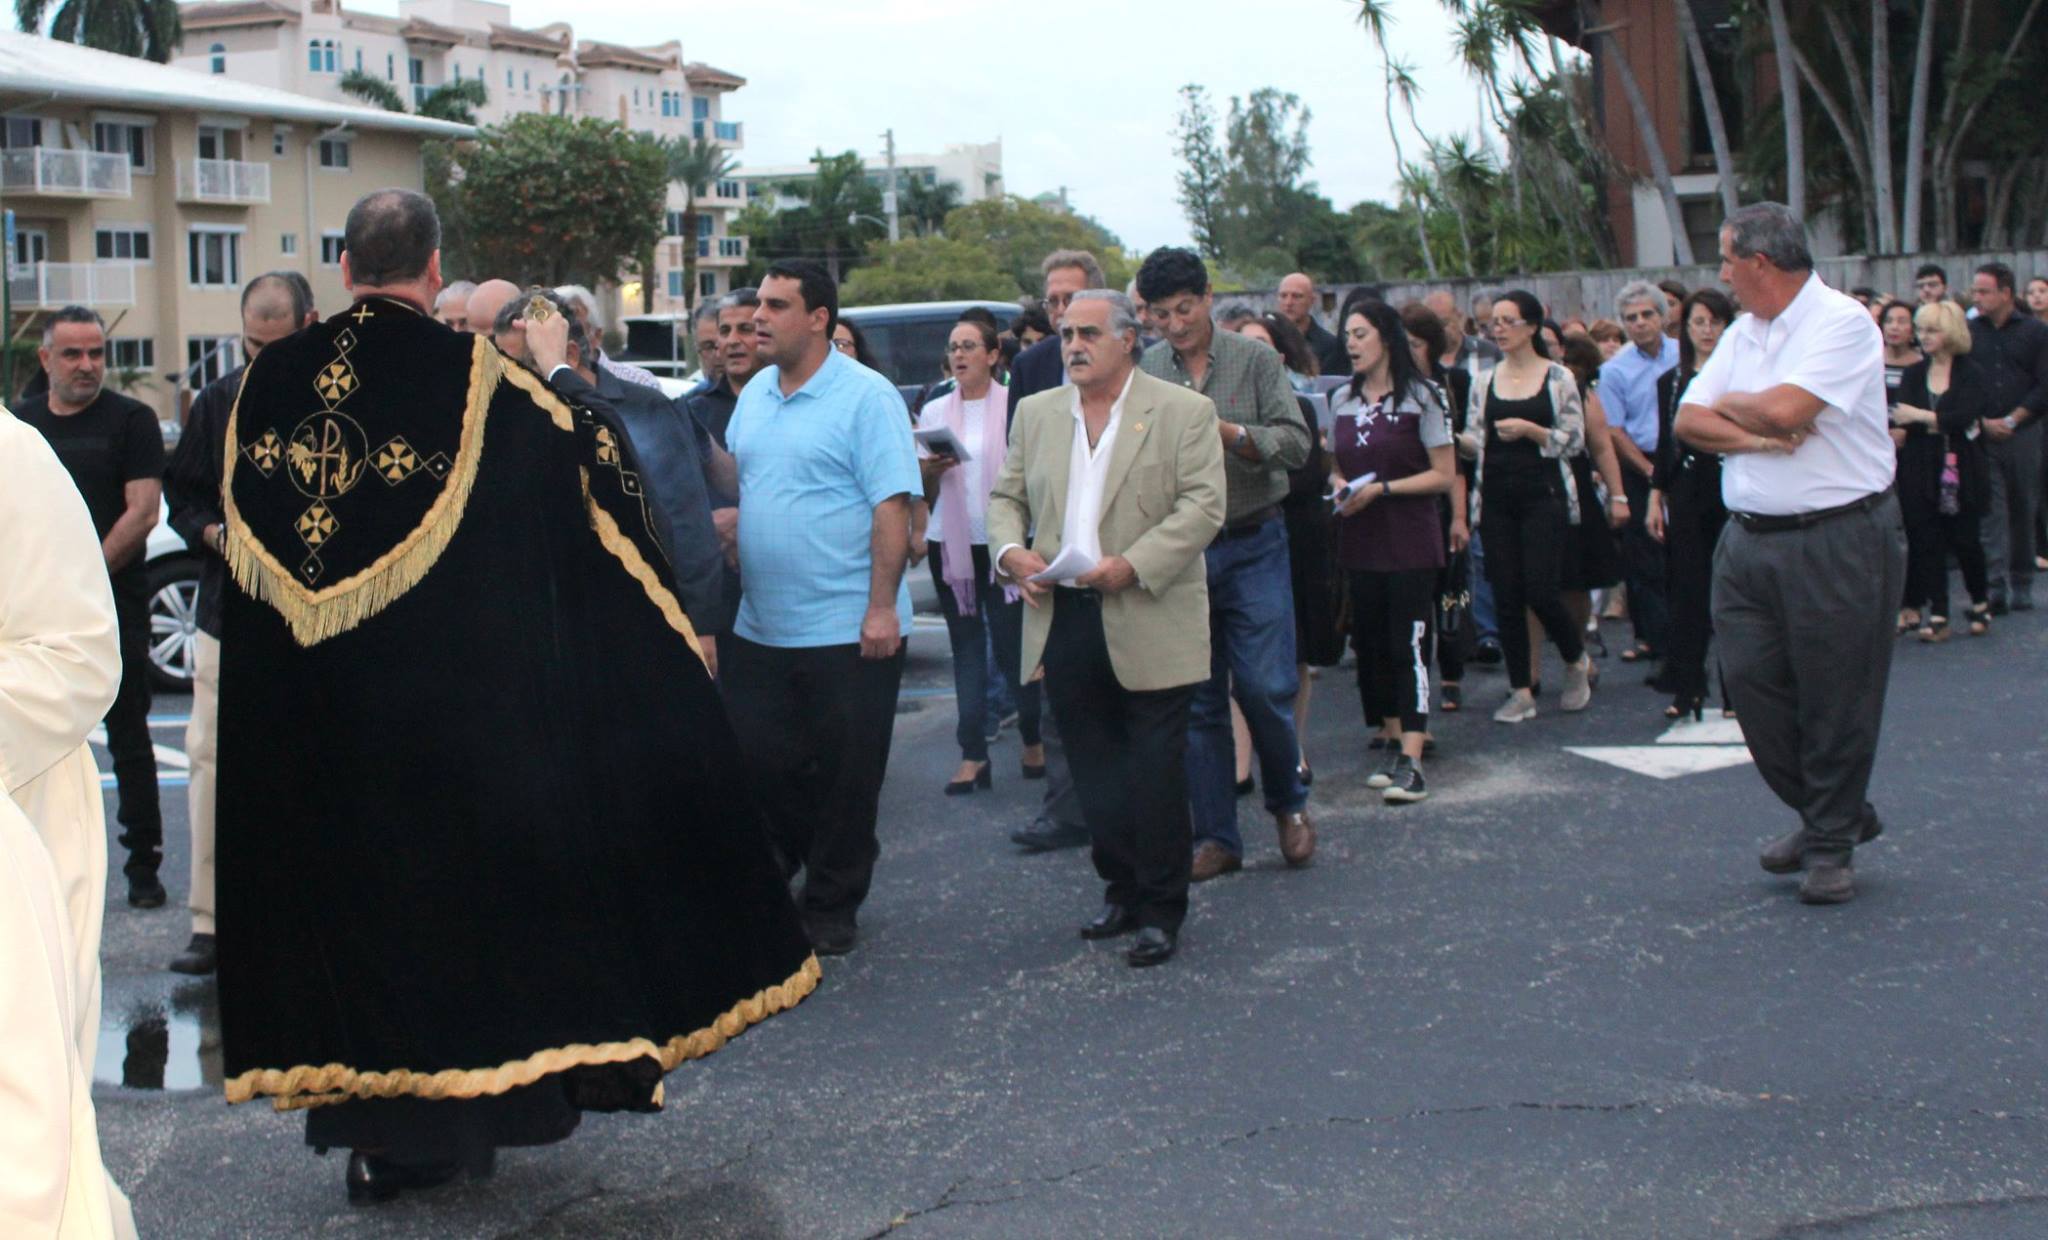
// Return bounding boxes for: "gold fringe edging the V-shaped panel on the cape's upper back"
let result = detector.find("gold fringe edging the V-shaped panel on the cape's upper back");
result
[221,336,506,646]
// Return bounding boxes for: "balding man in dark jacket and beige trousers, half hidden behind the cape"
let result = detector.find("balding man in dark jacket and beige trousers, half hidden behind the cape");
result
[164,271,317,976]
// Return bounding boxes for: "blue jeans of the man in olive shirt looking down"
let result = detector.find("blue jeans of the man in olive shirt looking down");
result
[1188,521,1309,857]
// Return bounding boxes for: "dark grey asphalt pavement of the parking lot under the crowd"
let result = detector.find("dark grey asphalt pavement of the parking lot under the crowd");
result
[94,602,2048,1238]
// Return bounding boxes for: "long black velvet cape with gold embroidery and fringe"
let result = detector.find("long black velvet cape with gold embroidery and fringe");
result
[217,299,817,1109]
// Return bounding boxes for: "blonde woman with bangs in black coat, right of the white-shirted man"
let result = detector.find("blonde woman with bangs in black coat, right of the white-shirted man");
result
[1892,301,1999,642]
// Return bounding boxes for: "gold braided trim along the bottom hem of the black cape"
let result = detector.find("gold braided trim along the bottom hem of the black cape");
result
[225,955,821,1111]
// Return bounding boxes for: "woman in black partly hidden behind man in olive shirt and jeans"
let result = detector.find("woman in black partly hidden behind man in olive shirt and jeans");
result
[1237,312,1343,785]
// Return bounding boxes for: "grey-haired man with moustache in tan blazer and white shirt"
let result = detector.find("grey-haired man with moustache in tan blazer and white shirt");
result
[989,289,1225,967]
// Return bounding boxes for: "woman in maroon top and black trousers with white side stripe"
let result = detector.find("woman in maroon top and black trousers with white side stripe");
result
[1329,293,1456,803]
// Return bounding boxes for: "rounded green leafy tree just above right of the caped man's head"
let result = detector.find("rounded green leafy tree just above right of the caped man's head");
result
[453,113,668,285]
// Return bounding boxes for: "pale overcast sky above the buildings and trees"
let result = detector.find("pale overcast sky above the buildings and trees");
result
[358,0,1515,250]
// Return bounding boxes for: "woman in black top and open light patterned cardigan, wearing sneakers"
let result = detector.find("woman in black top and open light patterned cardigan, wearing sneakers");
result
[1464,289,1593,724]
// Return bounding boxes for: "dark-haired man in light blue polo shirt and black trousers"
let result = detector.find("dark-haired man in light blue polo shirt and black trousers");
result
[721,260,924,955]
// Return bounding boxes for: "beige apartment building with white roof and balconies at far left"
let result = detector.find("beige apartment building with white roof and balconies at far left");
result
[0,31,473,422]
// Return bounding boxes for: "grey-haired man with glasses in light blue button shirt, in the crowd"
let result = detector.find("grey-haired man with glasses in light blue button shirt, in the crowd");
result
[1599,281,1683,662]
